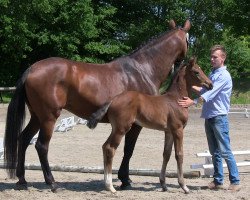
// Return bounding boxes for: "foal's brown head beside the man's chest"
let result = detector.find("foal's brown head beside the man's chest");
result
[185,58,213,90]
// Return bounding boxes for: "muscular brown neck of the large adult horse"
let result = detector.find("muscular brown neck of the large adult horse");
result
[130,33,182,87]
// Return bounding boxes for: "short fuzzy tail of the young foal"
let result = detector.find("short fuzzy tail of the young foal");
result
[87,101,112,129]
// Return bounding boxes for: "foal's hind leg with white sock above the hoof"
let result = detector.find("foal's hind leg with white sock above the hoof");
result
[102,131,124,193]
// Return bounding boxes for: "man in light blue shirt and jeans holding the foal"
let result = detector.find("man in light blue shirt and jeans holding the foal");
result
[179,45,240,191]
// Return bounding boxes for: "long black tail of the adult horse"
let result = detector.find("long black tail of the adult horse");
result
[4,67,29,178]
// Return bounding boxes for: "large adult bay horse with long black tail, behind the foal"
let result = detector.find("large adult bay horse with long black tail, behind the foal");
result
[4,20,191,191]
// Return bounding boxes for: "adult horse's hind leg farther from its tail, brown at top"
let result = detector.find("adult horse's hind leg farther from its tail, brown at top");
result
[35,119,57,192]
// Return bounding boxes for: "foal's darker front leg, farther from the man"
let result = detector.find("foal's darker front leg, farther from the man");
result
[160,131,173,191]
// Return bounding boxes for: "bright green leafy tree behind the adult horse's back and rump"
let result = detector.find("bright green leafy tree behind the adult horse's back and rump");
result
[0,0,127,85]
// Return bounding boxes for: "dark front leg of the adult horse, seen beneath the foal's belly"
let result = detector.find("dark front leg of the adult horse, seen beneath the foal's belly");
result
[118,124,142,190]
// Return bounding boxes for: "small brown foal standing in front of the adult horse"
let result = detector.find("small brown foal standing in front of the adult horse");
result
[87,58,213,193]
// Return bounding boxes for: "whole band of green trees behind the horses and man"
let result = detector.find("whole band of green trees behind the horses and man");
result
[0,0,250,94]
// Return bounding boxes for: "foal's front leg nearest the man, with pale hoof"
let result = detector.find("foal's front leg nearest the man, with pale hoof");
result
[173,128,189,194]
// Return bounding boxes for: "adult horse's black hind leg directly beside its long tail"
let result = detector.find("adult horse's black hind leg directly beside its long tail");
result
[16,114,39,189]
